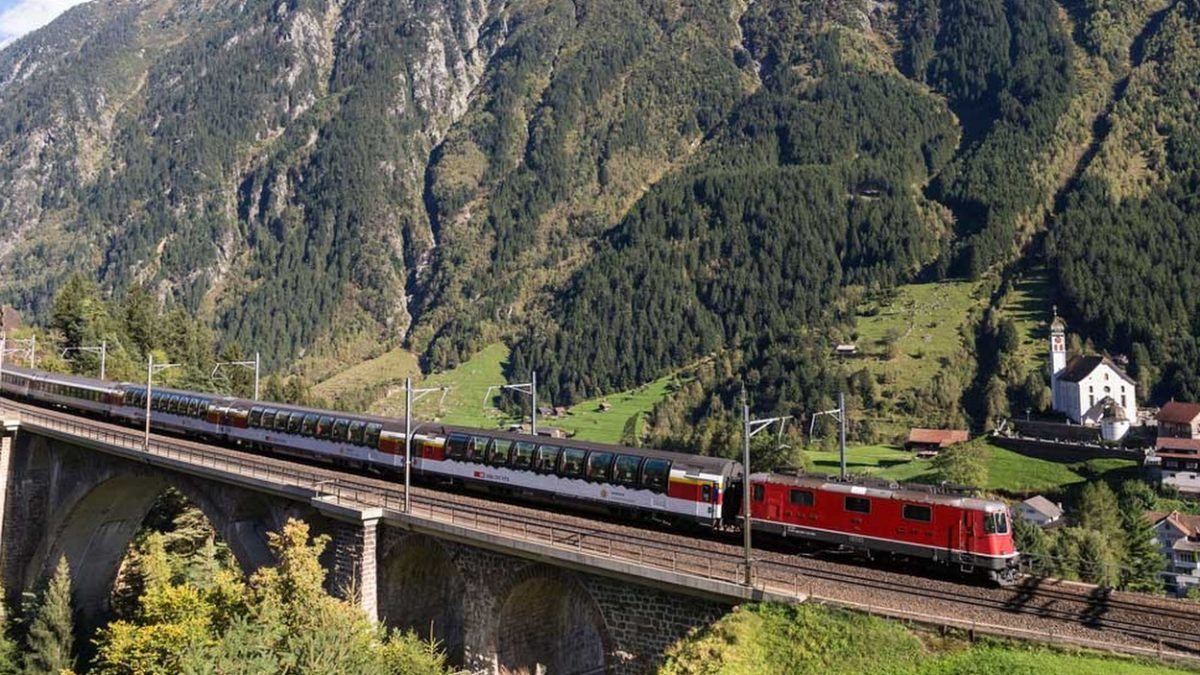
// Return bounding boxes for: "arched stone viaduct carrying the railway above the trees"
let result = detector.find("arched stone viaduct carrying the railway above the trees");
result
[0,416,777,674]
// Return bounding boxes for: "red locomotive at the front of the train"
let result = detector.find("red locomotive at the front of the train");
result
[750,473,1019,584]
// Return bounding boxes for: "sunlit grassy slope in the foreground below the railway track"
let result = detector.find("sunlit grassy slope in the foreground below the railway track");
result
[659,604,1193,675]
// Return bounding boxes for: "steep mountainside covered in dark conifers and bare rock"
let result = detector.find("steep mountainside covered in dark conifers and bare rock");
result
[0,0,1200,437]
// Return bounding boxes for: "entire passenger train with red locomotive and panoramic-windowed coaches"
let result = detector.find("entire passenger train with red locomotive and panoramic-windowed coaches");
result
[0,366,1020,584]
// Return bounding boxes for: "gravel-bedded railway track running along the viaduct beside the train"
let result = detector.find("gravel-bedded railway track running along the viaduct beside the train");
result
[5,401,1200,659]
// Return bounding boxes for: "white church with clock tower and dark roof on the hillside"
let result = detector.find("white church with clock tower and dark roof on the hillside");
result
[1050,312,1138,441]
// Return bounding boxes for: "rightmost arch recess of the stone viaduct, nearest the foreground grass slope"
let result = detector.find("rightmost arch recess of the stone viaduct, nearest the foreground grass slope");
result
[497,573,611,675]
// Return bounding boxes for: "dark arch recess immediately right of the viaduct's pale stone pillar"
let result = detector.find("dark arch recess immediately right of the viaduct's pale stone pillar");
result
[378,534,467,667]
